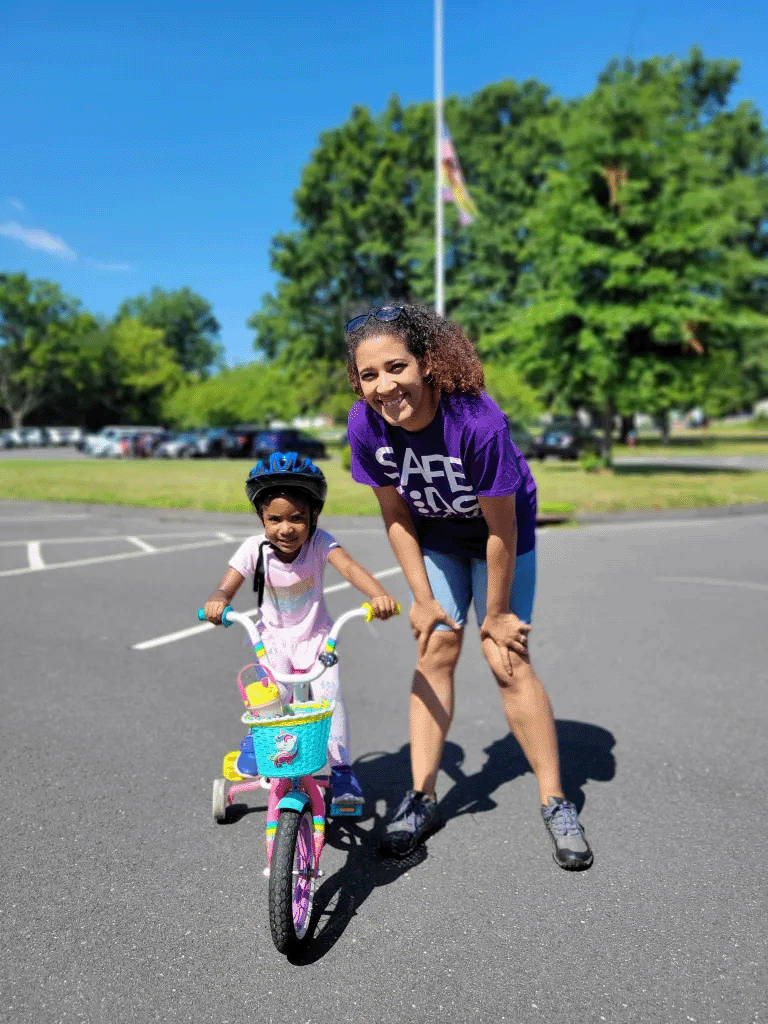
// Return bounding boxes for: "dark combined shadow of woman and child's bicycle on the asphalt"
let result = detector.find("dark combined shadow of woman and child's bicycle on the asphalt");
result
[291,720,616,966]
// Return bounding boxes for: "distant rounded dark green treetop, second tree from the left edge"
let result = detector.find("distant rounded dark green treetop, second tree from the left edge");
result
[115,288,223,378]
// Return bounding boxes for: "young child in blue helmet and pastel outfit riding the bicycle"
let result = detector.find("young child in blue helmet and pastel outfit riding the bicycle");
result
[205,452,397,804]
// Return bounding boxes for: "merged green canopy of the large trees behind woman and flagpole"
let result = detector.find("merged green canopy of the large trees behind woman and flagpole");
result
[249,49,768,434]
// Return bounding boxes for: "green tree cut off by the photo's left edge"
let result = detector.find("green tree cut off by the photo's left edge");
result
[0,273,96,426]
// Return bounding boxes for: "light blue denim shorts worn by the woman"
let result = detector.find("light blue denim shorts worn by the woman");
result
[422,548,536,630]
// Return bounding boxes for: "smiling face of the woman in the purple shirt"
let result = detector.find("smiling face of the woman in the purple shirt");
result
[354,334,440,430]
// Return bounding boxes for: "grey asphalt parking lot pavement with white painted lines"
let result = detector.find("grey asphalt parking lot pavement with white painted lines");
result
[0,501,768,1024]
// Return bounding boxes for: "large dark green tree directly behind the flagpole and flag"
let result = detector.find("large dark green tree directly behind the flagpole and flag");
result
[249,81,559,365]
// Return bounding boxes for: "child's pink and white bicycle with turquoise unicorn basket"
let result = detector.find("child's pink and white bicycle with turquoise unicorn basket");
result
[198,604,399,953]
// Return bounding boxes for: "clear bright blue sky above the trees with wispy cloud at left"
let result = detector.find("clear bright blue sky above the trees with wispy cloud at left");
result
[0,0,768,365]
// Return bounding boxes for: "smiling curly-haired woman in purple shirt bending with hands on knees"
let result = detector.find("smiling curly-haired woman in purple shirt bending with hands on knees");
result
[346,305,592,869]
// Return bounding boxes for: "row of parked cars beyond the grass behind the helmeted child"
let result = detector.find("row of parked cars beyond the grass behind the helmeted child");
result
[77,425,328,460]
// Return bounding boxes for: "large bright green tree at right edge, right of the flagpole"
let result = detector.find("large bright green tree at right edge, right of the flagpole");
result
[482,50,768,447]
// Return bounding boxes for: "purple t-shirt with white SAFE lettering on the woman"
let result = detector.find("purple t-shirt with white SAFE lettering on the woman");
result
[348,392,537,558]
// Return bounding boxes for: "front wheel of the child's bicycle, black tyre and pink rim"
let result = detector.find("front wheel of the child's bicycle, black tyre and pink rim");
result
[269,807,316,953]
